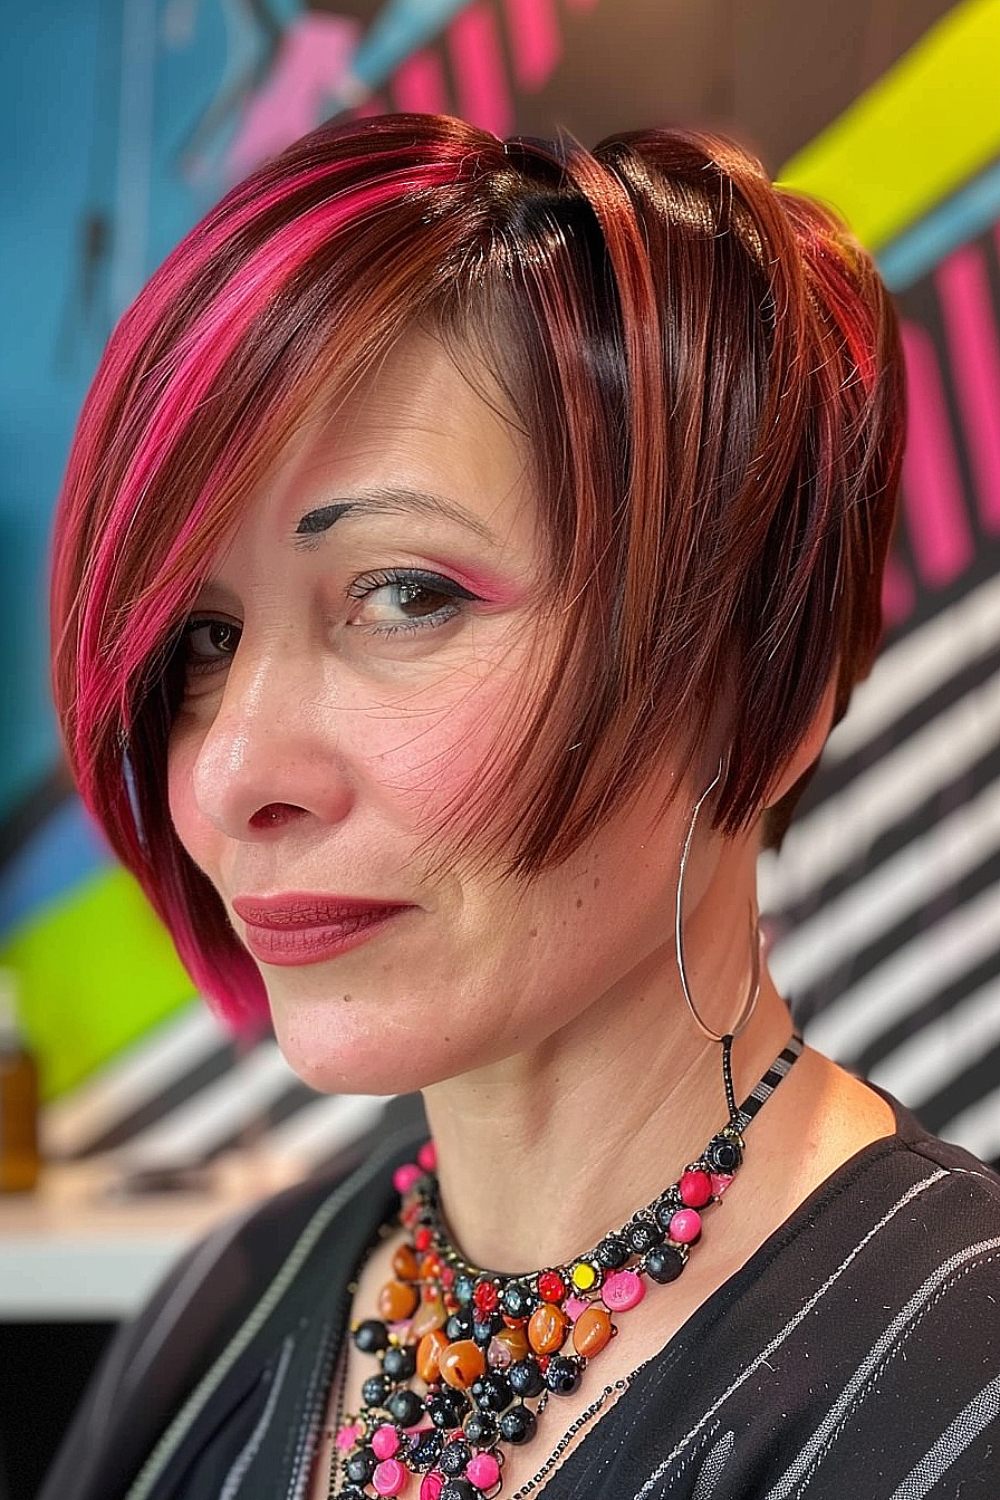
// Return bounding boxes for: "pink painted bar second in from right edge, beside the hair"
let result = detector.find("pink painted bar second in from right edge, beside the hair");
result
[903,323,973,588]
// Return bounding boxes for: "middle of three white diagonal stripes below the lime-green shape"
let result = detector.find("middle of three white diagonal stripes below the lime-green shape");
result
[120,1041,298,1170]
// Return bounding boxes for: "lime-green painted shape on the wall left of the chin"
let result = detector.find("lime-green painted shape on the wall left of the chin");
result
[0,867,193,1098]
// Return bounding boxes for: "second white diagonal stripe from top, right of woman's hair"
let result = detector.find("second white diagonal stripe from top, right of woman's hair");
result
[757,672,1000,912]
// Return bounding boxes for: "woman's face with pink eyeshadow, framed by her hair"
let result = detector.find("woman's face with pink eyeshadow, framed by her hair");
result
[169,338,695,1094]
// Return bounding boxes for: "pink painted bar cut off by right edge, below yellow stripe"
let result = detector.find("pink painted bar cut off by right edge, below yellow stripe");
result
[934,245,1000,531]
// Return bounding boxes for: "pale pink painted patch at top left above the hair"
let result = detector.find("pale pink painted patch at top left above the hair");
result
[226,11,361,177]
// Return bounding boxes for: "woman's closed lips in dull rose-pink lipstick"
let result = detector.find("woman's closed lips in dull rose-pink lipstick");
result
[232,891,411,965]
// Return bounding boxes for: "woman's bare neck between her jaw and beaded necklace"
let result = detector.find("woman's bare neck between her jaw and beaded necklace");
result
[424,840,790,1274]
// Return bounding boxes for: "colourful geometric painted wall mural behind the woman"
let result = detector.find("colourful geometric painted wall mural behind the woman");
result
[0,0,1000,1164]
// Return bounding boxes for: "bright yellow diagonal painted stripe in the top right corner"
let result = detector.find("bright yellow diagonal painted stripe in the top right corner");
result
[778,0,1000,251]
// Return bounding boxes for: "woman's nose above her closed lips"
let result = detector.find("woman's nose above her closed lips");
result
[190,641,354,840]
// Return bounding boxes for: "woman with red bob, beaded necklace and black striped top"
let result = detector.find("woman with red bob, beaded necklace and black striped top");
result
[46,116,1000,1500]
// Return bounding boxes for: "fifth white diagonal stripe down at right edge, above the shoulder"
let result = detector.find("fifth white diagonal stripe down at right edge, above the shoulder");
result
[871,980,1000,1109]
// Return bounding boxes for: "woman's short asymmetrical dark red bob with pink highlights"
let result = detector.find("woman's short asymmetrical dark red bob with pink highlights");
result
[52,116,904,1020]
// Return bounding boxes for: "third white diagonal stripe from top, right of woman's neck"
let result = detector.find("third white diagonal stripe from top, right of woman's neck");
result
[771,780,1000,995]
